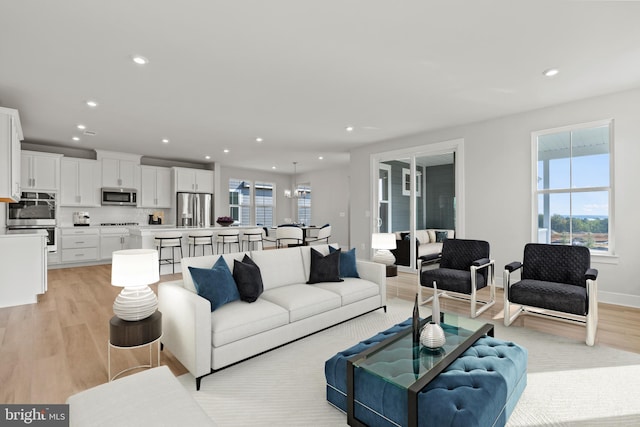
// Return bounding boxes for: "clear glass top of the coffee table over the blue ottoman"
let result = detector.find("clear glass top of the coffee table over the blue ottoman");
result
[353,312,493,388]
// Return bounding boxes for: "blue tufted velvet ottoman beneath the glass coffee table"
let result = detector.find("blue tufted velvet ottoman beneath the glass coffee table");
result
[325,319,527,427]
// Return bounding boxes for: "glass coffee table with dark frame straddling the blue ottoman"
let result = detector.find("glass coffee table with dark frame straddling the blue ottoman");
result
[347,312,493,427]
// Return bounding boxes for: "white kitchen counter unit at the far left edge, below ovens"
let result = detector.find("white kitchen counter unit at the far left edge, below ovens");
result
[0,229,48,307]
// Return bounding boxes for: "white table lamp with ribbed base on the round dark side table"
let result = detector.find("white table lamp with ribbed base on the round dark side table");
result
[111,249,160,321]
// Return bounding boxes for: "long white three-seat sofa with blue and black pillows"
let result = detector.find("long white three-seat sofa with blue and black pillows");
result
[158,245,386,389]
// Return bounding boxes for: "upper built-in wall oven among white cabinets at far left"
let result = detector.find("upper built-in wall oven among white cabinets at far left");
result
[7,191,57,227]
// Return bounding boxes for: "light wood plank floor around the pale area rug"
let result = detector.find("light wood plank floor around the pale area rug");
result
[0,265,640,404]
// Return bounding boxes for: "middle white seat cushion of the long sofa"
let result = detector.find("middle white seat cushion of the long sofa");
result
[260,284,342,322]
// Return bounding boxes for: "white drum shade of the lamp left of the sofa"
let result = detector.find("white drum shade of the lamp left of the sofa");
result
[111,249,160,288]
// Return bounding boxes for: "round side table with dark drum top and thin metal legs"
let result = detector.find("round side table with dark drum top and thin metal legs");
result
[107,310,162,382]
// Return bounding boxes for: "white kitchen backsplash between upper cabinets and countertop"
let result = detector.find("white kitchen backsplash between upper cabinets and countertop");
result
[58,206,170,227]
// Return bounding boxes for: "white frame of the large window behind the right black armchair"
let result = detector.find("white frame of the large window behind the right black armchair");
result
[531,119,615,259]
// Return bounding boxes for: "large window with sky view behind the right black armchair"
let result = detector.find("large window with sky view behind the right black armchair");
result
[532,120,613,254]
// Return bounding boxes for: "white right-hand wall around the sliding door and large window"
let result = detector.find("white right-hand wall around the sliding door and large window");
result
[350,90,640,307]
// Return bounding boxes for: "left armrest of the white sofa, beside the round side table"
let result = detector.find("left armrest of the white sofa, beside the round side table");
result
[158,281,211,378]
